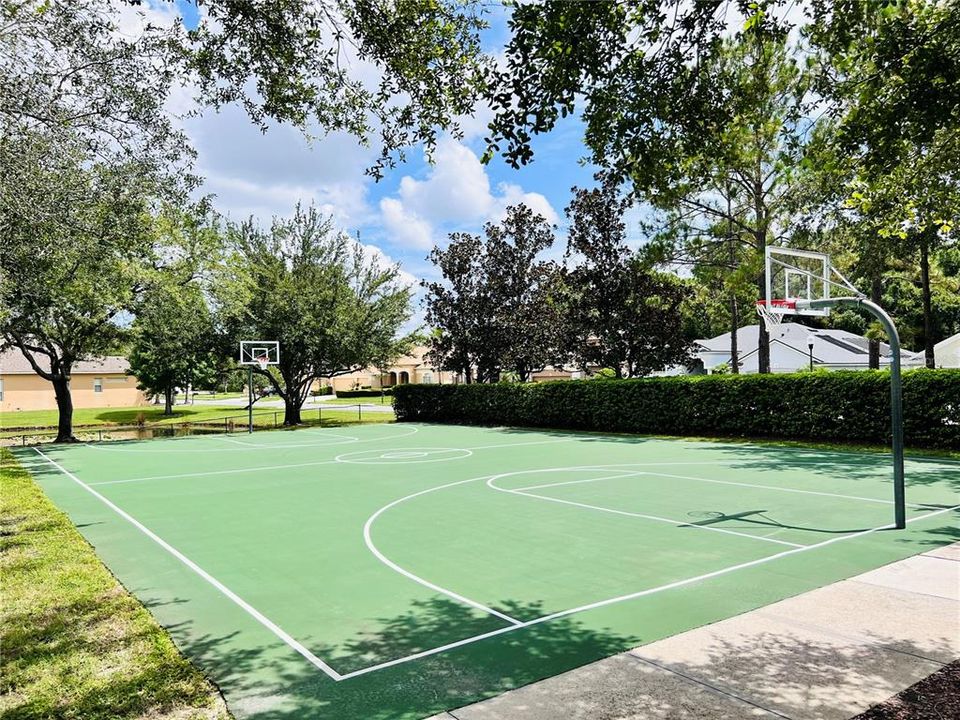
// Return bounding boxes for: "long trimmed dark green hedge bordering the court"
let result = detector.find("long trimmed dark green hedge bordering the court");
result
[393,369,960,450]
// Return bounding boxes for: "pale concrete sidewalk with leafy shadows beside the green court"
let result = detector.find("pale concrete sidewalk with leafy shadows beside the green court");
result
[431,543,960,720]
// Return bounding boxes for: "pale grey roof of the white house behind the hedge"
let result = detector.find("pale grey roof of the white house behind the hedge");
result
[696,322,920,366]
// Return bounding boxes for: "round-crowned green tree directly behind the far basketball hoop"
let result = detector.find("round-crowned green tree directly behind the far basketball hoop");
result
[213,206,413,425]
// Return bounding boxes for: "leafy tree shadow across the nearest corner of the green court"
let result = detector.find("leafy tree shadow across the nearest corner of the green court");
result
[158,598,640,720]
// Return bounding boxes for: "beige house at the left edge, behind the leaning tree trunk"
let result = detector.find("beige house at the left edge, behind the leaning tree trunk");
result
[0,349,146,412]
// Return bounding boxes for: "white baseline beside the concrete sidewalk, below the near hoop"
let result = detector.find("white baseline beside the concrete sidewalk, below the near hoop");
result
[340,500,960,680]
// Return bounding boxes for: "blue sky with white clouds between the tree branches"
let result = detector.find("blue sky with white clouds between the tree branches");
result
[165,0,593,290]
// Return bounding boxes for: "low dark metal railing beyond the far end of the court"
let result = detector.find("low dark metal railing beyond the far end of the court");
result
[0,403,392,447]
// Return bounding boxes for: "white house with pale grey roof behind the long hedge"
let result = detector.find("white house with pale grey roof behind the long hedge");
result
[695,322,928,373]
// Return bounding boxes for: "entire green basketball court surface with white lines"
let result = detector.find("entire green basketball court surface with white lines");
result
[17,424,960,720]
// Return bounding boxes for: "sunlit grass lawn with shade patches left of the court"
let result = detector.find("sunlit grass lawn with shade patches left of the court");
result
[0,450,230,720]
